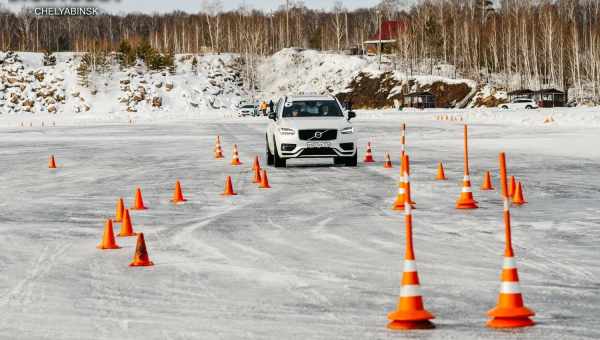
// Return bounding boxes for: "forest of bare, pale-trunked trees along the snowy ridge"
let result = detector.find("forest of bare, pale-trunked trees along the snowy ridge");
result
[0,0,600,99]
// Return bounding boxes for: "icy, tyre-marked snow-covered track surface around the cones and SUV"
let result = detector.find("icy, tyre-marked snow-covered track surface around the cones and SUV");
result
[0,113,600,340]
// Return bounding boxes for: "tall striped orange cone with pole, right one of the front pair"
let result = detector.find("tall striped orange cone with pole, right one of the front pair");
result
[487,152,535,328]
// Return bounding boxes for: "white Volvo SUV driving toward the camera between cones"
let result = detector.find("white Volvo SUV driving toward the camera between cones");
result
[266,96,357,167]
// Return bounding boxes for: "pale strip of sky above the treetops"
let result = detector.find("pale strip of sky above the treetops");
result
[0,0,394,13]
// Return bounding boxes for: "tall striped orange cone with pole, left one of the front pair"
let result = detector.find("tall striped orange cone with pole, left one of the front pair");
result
[387,182,435,330]
